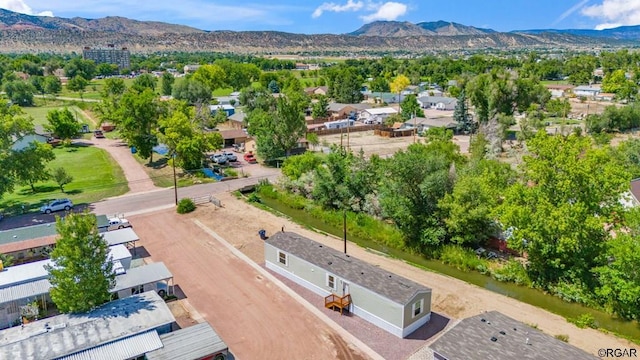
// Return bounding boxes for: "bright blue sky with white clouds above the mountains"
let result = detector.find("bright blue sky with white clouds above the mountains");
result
[0,0,640,34]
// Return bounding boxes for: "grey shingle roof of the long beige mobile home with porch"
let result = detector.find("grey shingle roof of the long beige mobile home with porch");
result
[266,232,431,305]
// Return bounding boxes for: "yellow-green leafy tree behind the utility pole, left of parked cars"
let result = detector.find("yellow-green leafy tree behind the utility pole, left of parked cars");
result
[160,108,223,170]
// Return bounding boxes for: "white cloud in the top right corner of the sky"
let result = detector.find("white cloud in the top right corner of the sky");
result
[582,0,640,30]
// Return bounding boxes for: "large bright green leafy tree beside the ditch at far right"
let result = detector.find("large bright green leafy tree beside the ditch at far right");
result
[497,131,629,290]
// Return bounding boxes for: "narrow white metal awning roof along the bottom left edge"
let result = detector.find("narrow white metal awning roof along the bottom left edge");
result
[56,330,162,360]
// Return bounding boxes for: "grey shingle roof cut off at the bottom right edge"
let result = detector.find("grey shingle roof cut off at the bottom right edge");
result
[430,311,598,360]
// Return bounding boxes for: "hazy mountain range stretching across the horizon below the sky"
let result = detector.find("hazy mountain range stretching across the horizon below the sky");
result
[0,9,640,53]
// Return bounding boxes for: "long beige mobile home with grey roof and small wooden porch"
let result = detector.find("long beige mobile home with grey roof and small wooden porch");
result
[264,232,431,338]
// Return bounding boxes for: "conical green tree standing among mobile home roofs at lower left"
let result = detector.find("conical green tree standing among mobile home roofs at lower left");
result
[46,212,115,313]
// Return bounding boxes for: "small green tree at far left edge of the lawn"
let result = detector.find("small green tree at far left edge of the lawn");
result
[13,141,56,193]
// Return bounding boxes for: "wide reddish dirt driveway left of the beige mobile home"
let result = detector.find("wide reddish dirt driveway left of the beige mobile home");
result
[129,209,366,360]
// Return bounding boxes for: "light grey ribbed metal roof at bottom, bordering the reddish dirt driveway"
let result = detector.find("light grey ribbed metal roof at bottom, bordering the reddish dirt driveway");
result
[147,322,229,360]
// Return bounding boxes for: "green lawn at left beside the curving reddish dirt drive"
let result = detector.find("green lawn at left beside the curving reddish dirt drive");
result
[0,146,128,214]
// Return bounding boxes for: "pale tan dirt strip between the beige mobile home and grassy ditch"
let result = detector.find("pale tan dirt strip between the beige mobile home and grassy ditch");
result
[192,194,637,355]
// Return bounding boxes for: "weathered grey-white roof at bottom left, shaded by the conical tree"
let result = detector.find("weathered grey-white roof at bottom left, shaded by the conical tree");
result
[0,291,175,360]
